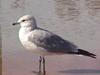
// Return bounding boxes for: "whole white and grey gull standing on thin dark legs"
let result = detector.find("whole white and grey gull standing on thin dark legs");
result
[13,15,96,74]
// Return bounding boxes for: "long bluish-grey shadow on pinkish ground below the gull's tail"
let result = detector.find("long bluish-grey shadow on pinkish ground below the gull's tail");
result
[59,69,100,74]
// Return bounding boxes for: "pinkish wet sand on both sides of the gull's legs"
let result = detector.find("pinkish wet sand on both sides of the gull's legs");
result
[3,51,100,75]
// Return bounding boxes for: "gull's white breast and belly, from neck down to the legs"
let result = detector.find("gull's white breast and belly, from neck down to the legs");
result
[19,29,51,55]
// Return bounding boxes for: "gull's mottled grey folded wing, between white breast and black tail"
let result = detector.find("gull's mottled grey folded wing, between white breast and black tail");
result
[29,30,78,53]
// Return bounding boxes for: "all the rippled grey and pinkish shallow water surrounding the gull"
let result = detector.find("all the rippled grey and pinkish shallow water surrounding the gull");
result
[0,0,100,75]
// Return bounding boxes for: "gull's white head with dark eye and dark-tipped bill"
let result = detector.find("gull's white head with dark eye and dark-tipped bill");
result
[13,15,37,27]
